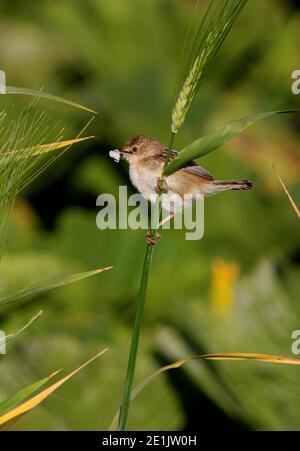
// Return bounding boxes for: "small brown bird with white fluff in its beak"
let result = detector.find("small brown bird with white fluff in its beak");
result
[113,135,253,244]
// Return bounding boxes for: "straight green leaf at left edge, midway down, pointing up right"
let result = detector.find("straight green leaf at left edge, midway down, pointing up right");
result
[0,266,112,307]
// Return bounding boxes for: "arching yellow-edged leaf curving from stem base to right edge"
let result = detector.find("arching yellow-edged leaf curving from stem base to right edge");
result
[109,352,300,430]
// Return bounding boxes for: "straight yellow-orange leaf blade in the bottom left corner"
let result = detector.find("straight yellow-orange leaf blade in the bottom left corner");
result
[0,348,108,430]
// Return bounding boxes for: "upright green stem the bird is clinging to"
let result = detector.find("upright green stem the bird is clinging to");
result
[118,133,175,431]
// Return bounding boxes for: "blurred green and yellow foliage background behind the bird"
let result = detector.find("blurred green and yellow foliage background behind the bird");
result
[0,0,300,431]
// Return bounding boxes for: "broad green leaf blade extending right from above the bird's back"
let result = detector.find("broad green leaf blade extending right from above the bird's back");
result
[165,110,298,175]
